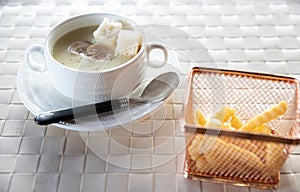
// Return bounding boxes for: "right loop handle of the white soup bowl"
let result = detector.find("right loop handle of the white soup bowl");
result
[146,44,168,68]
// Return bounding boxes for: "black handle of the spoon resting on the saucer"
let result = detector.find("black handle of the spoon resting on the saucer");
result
[34,98,129,125]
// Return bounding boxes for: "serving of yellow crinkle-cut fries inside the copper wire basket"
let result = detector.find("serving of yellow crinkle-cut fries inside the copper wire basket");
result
[188,101,287,177]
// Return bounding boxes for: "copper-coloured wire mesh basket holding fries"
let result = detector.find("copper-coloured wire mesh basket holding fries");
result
[183,68,300,188]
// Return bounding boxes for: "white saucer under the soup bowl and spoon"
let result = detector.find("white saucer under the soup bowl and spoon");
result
[17,50,179,131]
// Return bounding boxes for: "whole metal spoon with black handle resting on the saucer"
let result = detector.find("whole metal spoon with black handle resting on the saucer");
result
[34,72,179,125]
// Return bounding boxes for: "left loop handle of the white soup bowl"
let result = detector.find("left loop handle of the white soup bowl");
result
[25,44,47,72]
